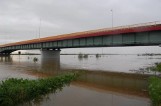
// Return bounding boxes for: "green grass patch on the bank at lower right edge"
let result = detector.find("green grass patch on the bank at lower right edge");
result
[149,76,161,106]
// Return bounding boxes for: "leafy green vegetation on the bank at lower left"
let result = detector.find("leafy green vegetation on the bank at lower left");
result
[0,73,78,106]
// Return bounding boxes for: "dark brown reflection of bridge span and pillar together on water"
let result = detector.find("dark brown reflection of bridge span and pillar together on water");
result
[30,58,149,97]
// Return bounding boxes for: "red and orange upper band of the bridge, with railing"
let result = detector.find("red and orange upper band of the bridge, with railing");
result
[0,22,161,47]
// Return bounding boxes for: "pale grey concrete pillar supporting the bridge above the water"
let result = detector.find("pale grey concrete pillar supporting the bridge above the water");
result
[41,49,61,59]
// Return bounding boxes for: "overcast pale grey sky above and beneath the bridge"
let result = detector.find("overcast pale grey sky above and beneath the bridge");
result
[0,0,161,53]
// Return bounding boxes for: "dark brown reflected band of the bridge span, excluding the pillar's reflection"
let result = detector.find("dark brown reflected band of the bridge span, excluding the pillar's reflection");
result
[74,71,149,97]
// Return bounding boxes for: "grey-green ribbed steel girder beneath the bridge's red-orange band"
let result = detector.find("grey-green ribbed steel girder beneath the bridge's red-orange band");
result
[0,30,161,54]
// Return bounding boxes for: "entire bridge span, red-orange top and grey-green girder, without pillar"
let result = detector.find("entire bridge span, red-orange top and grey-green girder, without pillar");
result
[0,22,161,55]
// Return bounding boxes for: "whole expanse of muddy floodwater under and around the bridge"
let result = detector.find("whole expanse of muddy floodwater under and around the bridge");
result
[0,55,161,106]
